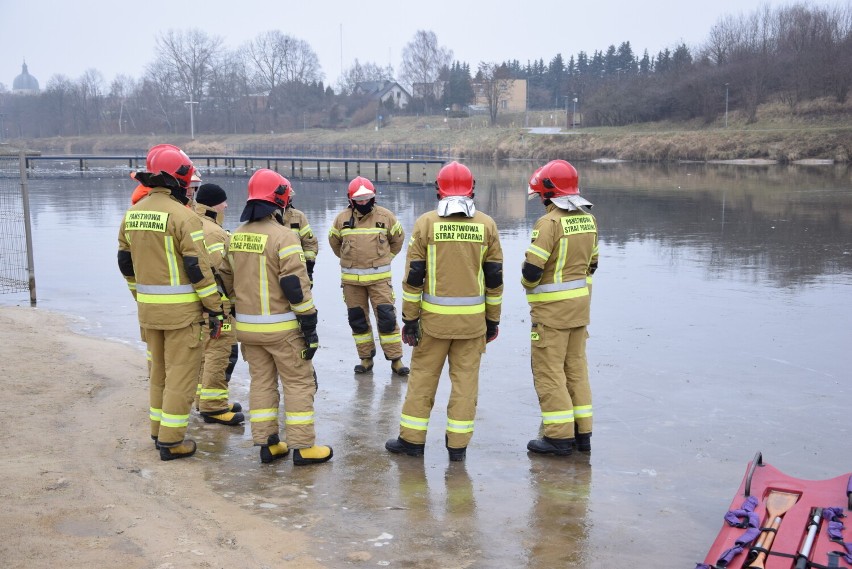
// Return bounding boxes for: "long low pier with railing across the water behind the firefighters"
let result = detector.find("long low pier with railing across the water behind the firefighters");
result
[21,154,446,184]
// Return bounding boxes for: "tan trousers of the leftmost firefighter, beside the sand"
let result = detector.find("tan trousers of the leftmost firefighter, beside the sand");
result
[145,323,204,446]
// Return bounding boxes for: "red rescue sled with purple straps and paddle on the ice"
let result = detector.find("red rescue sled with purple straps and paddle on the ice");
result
[696,452,852,569]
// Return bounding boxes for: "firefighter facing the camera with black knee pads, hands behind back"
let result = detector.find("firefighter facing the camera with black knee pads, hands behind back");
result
[328,176,409,375]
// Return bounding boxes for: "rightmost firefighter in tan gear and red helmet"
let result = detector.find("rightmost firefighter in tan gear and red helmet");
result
[521,160,598,456]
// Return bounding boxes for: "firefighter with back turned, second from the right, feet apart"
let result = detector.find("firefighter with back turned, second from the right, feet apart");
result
[385,162,503,461]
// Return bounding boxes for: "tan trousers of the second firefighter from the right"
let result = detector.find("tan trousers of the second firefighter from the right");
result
[399,333,485,448]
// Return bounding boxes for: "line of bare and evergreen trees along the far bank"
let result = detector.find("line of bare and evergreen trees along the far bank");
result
[0,3,852,138]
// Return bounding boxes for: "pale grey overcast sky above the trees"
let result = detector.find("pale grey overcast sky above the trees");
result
[0,0,824,89]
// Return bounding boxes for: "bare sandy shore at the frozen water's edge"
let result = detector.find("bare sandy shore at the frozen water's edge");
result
[0,307,321,569]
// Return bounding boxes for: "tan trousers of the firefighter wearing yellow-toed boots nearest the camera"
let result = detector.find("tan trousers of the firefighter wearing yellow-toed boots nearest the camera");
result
[243,330,317,448]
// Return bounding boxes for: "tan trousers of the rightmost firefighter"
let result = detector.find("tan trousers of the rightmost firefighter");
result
[530,324,592,439]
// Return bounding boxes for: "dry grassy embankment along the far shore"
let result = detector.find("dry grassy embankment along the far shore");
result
[5,97,852,163]
